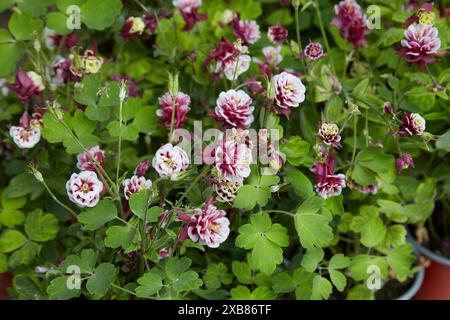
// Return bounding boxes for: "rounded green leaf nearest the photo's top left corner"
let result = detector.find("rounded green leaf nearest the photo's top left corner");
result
[8,12,43,40]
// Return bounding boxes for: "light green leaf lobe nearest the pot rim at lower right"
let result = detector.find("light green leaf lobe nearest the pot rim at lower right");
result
[387,244,416,282]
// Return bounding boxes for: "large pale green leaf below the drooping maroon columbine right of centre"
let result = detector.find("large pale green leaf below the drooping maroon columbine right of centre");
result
[294,196,333,249]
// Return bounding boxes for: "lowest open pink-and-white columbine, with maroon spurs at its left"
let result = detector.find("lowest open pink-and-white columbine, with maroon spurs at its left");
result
[178,198,230,248]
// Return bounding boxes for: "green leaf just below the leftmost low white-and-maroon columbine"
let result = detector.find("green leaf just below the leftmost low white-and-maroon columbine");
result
[78,199,117,230]
